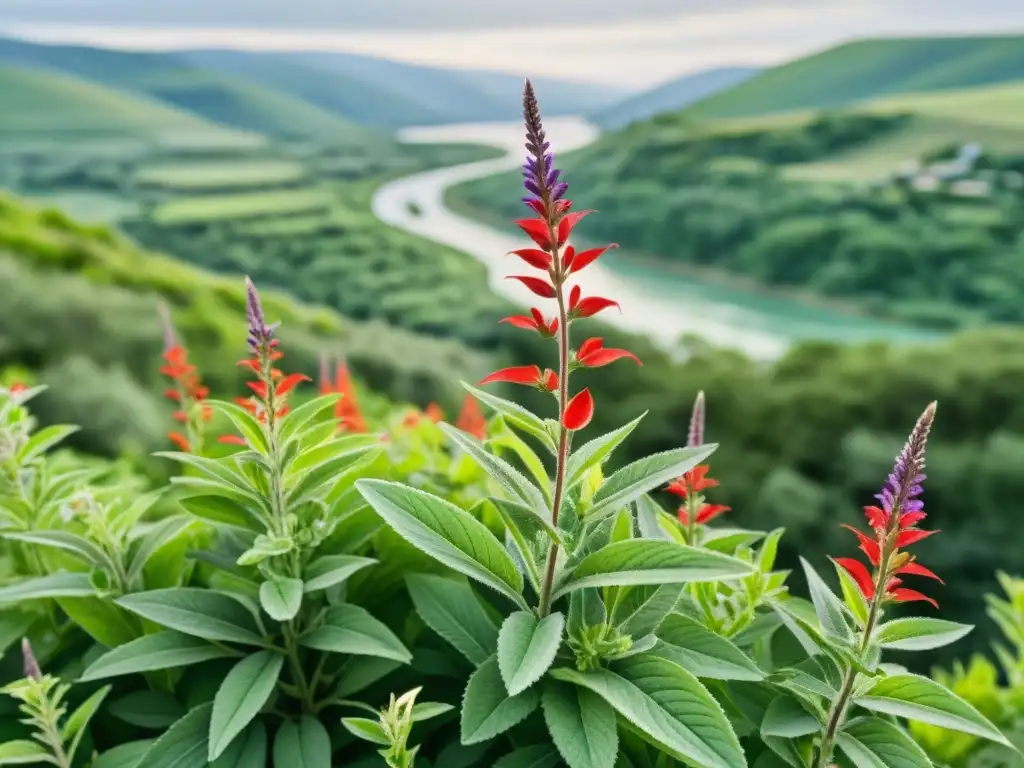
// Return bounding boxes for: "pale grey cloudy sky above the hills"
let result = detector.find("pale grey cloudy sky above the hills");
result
[0,0,1024,87]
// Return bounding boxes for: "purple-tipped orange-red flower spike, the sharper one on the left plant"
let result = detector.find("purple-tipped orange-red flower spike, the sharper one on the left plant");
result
[219,278,309,445]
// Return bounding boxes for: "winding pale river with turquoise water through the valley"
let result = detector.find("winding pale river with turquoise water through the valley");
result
[373,118,938,358]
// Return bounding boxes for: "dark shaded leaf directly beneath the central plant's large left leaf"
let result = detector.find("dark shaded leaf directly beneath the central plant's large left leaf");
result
[406,573,498,666]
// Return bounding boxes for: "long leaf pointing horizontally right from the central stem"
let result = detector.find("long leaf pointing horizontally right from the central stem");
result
[555,539,753,598]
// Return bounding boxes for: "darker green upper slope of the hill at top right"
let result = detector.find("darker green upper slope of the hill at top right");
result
[688,36,1024,118]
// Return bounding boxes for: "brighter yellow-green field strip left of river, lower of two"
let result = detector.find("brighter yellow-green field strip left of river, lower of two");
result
[152,187,334,226]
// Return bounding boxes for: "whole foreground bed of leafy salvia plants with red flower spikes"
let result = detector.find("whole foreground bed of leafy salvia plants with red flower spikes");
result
[0,83,1022,768]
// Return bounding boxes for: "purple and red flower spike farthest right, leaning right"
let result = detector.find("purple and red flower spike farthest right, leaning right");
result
[836,402,942,608]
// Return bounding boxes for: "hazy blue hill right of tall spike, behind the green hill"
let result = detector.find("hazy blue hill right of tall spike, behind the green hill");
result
[592,67,760,129]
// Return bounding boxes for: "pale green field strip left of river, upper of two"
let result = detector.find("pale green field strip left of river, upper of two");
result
[135,160,306,191]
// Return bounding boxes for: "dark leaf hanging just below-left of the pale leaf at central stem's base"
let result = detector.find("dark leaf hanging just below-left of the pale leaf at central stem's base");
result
[461,656,541,744]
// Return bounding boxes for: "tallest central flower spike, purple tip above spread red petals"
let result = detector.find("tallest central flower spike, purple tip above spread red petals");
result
[480,80,640,431]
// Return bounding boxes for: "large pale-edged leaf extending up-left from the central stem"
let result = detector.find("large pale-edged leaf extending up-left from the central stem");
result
[355,479,528,609]
